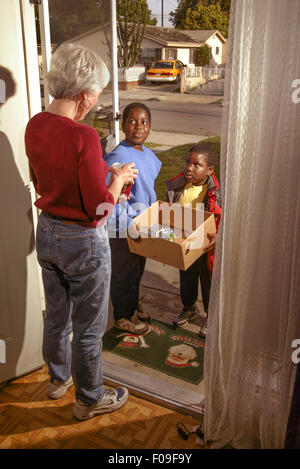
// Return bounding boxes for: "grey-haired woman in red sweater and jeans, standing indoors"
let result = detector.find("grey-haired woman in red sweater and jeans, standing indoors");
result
[25,44,137,420]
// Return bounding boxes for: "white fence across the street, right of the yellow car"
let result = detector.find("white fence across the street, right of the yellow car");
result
[180,67,225,93]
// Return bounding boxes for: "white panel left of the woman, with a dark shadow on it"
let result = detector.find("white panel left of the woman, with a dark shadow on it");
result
[0,0,43,383]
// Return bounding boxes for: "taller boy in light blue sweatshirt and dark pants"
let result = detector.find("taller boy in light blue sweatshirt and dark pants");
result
[105,103,161,334]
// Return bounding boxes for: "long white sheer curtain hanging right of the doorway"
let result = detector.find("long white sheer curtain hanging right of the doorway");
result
[204,0,300,448]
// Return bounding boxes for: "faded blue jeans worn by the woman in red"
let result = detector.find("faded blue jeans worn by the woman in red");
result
[36,212,111,404]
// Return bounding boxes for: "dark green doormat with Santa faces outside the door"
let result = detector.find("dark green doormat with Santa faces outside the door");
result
[103,320,205,384]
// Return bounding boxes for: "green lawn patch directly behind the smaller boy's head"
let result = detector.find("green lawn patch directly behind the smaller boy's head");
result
[154,137,221,200]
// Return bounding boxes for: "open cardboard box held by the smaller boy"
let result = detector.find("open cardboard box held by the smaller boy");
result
[127,201,216,270]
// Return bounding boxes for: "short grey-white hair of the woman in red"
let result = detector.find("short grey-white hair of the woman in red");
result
[46,42,110,99]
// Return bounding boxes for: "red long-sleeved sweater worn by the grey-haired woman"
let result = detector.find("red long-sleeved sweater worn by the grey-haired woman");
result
[25,112,114,227]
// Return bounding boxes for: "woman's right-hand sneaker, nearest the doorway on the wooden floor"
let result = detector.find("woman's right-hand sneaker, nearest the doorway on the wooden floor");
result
[73,386,128,420]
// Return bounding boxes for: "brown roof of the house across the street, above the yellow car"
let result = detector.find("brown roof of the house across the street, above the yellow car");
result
[144,25,226,47]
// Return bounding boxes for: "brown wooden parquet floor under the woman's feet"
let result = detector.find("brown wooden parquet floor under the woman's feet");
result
[0,367,202,449]
